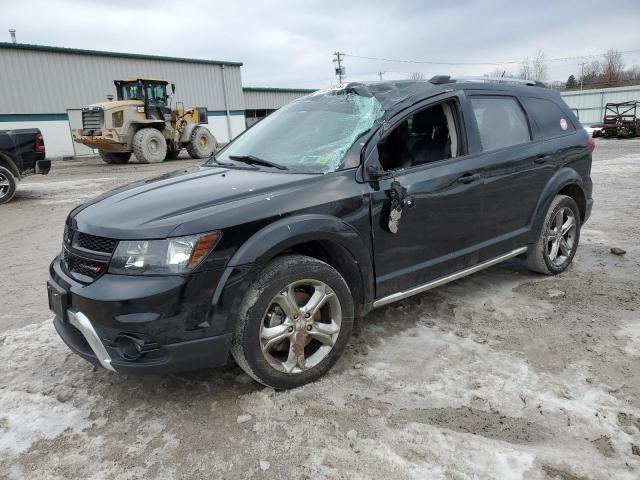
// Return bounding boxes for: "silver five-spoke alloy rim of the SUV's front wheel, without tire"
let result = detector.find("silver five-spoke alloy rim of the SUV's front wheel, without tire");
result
[260,280,342,373]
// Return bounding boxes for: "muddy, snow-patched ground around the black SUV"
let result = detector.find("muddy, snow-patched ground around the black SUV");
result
[0,140,640,480]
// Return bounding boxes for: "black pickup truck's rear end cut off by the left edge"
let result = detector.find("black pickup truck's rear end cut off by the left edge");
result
[0,128,51,204]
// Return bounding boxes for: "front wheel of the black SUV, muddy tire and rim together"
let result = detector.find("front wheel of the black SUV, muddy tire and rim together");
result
[231,255,354,389]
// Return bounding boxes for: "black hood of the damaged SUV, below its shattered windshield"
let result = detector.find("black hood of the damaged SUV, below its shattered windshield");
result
[70,166,322,240]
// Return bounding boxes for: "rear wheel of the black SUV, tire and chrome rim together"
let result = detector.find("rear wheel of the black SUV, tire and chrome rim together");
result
[527,195,582,275]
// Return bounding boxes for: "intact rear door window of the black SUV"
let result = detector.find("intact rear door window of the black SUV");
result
[471,96,531,152]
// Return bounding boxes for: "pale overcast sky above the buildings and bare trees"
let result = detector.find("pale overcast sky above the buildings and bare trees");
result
[0,0,640,88]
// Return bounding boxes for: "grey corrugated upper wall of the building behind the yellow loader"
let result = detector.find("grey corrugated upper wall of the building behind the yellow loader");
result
[0,46,244,114]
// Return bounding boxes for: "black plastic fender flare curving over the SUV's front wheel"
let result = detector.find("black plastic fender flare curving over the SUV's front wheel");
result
[212,214,375,304]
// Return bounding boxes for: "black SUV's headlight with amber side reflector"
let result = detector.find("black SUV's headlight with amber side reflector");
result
[109,232,220,275]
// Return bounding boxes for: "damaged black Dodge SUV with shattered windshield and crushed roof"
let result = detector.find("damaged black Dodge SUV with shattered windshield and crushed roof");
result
[48,77,594,388]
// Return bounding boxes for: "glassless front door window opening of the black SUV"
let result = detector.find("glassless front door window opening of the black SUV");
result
[378,102,460,170]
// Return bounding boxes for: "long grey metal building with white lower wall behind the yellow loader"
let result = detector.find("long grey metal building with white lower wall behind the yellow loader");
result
[0,43,246,157]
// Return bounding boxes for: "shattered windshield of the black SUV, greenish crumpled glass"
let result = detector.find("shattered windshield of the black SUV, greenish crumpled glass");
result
[210,90,382,173]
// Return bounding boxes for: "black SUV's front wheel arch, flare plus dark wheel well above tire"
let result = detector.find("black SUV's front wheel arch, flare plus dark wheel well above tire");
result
[214,214,374,315]
